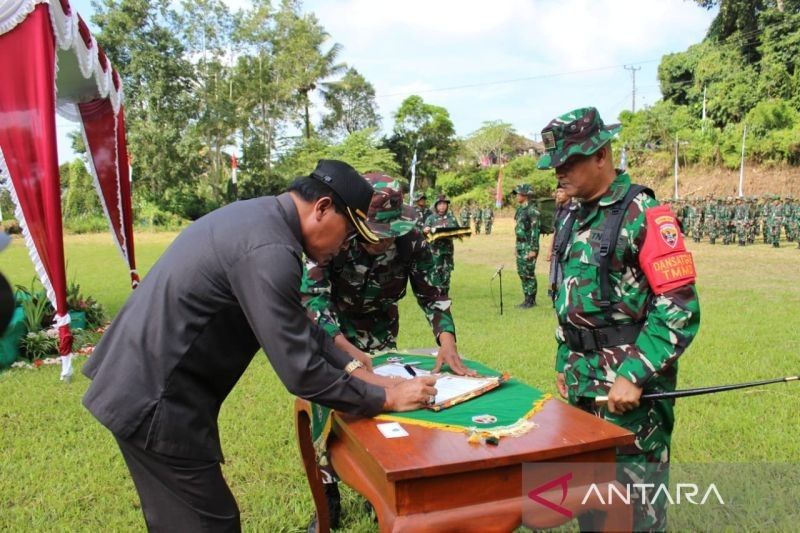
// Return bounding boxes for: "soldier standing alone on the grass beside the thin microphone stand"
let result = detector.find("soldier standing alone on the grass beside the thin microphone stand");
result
[514,183,542,309]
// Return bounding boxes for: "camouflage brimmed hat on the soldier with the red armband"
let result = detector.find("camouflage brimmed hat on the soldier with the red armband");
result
[538,107,622,170]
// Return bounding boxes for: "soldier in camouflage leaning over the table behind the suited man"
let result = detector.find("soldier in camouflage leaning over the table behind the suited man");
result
[301,174,474,530]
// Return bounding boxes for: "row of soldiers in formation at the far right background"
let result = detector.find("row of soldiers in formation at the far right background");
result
[672,195,800,248]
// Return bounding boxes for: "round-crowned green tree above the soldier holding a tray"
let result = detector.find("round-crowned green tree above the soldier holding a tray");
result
[386,95,458,188]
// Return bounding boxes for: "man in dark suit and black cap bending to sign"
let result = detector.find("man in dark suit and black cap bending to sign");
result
[83,160,436,531]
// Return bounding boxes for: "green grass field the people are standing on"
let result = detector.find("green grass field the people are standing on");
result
[0,218,800,531]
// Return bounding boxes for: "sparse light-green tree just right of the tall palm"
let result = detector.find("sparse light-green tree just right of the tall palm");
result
[322,68,381,136]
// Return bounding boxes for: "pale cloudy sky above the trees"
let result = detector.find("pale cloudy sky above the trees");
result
[58,0,716,161]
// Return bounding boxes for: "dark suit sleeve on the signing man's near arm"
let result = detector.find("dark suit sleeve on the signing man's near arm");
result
[228,245,385,416]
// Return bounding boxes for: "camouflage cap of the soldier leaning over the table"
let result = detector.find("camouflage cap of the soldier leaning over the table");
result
[364,173,416,239]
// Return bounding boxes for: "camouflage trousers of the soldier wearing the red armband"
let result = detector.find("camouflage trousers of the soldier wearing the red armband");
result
[570,398,675,531]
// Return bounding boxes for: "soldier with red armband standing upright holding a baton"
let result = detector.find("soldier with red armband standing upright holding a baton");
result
[538,108,700,531]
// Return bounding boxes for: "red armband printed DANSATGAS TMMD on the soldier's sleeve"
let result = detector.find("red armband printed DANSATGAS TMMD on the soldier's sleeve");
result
[639,205,697,294]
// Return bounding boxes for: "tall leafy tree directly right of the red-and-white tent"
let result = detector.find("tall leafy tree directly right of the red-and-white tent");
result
[92,0,201,202]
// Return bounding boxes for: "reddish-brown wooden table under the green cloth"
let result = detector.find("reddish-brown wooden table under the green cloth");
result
[296,392,634,533]
